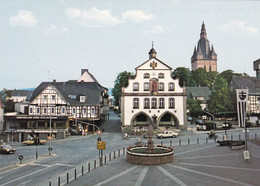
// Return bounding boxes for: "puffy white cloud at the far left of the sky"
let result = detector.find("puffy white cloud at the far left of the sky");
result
[9,10,38,27]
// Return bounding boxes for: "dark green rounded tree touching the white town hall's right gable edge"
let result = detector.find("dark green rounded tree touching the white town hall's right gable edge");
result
[172,67,195,87]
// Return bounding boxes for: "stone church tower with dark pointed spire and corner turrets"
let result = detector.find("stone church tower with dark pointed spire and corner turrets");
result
[191,22,217,72]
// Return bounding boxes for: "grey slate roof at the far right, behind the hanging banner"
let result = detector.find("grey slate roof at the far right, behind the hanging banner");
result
[230,76,260,95]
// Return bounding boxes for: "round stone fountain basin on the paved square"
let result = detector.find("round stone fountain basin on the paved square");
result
[126,146,174,165]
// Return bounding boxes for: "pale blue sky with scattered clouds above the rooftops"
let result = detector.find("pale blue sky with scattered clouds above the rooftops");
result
[0,0,260,90]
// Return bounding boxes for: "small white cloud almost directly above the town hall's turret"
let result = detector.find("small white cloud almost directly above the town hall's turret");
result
[122,10,154,23]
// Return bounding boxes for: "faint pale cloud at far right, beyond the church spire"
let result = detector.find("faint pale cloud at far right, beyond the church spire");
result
[219,20,259,35]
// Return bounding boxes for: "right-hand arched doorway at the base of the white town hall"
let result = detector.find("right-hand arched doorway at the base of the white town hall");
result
[158,112,179,128]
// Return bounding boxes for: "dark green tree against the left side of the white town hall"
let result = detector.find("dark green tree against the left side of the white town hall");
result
[112,71,135,106]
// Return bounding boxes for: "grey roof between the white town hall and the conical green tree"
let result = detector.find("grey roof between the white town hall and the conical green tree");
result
[186,87,210,103]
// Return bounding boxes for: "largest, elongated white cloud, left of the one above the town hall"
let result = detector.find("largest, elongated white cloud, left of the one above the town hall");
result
[66,7,121,27]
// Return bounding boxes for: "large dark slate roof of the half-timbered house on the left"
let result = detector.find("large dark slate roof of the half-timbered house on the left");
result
[31,80,104,105]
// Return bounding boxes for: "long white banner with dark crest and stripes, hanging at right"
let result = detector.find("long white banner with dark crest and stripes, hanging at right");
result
[236,89,248,127]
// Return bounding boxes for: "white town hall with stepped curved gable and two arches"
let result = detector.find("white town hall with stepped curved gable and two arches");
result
[121,47,187,130]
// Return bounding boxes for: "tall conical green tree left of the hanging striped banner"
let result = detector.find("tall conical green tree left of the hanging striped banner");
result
[207,75,231,113]
